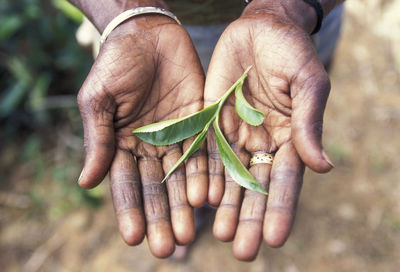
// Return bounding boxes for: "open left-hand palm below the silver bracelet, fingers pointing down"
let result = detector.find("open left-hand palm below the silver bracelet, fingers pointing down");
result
[78,15,208,257]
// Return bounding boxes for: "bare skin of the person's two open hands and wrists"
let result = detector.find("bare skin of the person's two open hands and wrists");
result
[71,0,339,260]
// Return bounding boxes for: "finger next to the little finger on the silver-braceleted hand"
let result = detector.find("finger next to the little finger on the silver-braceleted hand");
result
[163,145,195,245]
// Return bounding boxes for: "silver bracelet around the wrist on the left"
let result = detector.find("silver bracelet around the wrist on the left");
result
[100,7,181,48]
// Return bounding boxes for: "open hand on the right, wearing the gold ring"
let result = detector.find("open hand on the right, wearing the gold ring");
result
[205,1,332,260]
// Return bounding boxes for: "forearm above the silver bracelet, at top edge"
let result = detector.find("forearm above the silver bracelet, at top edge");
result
[69,0,167,33]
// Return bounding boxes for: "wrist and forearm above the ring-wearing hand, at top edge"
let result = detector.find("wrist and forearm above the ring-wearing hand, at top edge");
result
[243,0,345,33]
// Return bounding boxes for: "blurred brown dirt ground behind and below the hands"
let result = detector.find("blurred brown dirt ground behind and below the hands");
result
[0,0,400,272]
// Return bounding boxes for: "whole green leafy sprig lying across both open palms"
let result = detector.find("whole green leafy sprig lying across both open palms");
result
[133,67,267,194]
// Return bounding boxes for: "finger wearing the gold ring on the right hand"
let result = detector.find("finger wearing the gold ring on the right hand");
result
[233,164,271,261]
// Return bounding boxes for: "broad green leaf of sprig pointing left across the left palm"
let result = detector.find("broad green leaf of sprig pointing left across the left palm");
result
[133,104,218,145]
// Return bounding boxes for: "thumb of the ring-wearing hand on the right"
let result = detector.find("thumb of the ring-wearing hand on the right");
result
[291,59,333,173]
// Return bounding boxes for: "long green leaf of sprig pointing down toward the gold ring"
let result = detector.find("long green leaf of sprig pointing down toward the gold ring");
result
[214,120,268,194]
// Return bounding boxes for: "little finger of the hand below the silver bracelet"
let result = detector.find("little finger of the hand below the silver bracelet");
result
[183,139,208,207]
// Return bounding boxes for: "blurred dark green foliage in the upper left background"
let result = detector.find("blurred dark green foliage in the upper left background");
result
[0,0,92,137]
